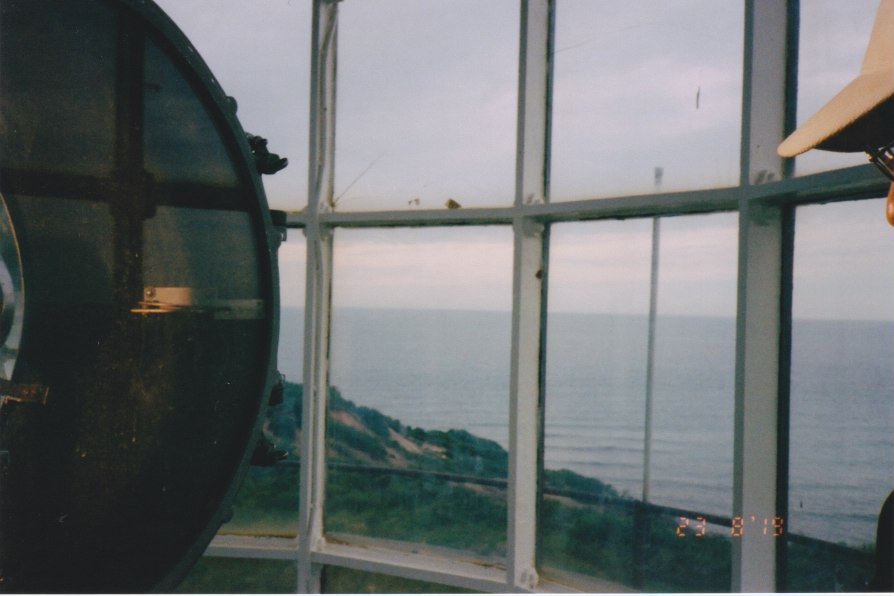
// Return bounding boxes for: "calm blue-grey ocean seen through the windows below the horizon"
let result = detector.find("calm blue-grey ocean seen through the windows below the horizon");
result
[279,308,894,545]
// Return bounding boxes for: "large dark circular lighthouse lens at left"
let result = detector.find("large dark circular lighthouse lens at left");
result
[0,0,278,592]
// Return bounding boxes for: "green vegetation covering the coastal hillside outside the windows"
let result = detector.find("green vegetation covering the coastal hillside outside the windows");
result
[181,384,872,592]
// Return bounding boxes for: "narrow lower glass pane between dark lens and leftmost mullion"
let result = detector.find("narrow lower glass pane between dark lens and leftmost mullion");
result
[220,236,306,538]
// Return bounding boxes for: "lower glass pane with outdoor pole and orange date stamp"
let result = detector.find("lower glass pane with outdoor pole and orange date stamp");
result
[540,214,738,591]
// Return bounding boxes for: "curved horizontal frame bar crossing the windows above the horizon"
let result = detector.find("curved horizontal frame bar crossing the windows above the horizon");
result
[285,164,889,229]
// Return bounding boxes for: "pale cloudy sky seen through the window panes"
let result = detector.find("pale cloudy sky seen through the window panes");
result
[158,0,894,320]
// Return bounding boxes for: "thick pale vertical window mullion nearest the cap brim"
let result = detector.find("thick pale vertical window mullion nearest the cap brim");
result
[731,0,790,592]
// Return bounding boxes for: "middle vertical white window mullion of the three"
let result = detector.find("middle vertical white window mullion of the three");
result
[507,0,554,591]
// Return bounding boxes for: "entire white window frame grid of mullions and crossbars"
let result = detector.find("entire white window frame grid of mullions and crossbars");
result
[207,0,886,592]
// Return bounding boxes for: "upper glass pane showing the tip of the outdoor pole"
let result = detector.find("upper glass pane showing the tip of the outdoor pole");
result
[551,0,744,200]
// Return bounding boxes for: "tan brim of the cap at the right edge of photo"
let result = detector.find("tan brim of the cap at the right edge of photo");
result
[777,71,894,157]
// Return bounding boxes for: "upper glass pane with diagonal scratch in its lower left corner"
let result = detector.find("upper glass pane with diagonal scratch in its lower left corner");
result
[335,0,519,210]
